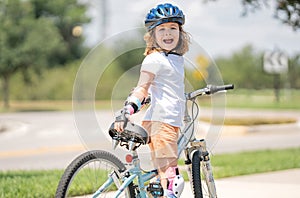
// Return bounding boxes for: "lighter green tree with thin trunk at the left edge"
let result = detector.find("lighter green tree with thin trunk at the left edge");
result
[0,0,65,108]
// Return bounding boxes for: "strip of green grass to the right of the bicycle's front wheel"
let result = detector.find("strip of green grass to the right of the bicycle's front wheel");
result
[179,148,300,179]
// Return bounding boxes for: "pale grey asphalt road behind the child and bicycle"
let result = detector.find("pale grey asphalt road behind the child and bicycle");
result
[0,110,300,170]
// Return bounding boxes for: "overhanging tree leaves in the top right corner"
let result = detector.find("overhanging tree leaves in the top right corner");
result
[210,0,300,30]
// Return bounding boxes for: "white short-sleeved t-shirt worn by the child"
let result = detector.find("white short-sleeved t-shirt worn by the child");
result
[141,52,185,127]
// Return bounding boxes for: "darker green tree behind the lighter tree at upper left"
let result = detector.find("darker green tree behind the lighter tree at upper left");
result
[30,0,90,65]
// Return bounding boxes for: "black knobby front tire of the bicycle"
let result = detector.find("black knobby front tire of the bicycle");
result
[192,151,212,198]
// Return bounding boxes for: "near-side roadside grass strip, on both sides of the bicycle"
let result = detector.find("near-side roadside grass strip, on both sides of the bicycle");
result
[0,147,300,198]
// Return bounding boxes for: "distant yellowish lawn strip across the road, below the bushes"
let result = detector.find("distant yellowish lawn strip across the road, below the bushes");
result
[0,88,300,112]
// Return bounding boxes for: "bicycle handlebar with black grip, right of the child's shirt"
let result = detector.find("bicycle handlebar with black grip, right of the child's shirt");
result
[186,84,234,100]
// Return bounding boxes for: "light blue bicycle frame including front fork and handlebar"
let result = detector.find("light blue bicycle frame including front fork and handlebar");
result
[93,85,233,198]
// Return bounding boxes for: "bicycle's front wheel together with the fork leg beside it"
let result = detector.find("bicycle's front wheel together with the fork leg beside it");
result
[192,151,217,198]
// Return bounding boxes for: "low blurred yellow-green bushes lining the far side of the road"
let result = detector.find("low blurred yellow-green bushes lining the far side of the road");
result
[4,45,300,100]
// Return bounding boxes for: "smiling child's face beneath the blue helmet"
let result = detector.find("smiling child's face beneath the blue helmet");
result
[155,22,180,51]
